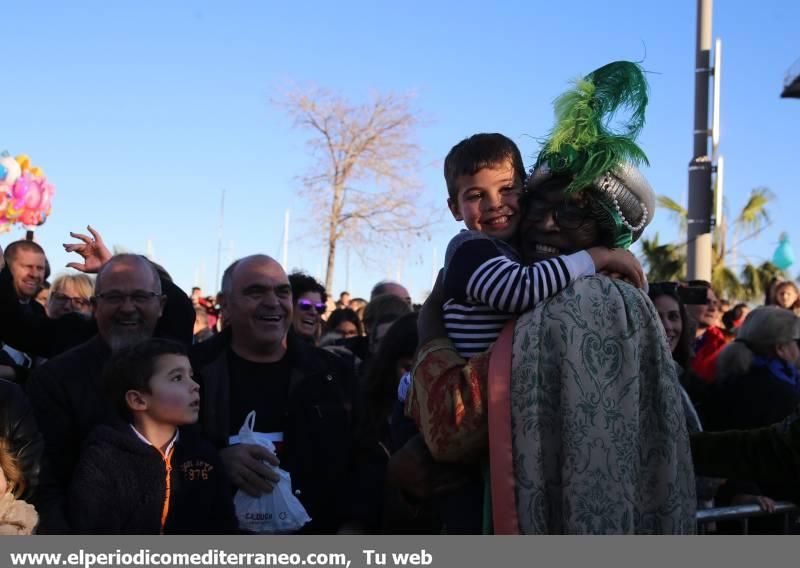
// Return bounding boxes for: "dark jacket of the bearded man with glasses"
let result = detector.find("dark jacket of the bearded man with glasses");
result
[27,337,115,533]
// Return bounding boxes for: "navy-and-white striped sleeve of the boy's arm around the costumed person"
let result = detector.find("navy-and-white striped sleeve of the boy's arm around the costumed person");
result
[444,239,595,313]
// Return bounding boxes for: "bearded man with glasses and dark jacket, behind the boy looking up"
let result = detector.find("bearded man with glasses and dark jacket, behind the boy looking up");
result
[28,254,191,533]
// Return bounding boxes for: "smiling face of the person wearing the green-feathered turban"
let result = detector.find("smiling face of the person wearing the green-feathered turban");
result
[519,187,600,263]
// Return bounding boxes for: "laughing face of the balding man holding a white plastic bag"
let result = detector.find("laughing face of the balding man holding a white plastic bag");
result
[222,258,292,352]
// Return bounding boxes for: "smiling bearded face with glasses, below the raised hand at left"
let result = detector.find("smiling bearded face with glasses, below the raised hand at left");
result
[94,259,165,351]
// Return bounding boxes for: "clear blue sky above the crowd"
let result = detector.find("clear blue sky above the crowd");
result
[0,0,800,300]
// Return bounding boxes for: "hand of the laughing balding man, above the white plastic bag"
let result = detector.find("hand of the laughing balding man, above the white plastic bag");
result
[219,444,280,497]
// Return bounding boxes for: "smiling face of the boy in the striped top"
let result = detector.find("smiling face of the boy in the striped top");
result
[447,160,522,241]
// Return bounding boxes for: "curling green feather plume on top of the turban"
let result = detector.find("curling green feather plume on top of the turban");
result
[536,61,648,193]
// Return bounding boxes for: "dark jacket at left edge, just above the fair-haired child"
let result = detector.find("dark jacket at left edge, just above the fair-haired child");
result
[0,380,44,502]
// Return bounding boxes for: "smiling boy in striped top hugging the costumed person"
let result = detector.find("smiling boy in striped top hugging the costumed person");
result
[442,134,639,358]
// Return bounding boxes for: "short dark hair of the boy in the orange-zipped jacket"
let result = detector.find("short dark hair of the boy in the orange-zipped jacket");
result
[103,338,188,421]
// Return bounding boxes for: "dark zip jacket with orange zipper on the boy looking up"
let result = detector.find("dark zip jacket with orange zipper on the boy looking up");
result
[69,423,237,534]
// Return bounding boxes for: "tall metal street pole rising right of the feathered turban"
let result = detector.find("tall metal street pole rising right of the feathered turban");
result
[687,0,714,282]
